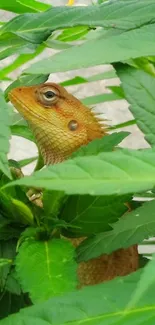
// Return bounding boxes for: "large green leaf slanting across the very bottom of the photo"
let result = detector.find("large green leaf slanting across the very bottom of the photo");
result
[1,269,155,325]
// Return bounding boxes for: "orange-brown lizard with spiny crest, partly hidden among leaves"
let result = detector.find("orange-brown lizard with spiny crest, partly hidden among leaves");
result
[9,83,138,286]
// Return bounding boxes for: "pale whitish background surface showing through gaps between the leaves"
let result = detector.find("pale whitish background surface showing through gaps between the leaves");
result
[0,0,152,252]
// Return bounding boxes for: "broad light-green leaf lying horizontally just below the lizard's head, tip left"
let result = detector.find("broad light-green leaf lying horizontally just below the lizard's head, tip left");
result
[6,149,155,195]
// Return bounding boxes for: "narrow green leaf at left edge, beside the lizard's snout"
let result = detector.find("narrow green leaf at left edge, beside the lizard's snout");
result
[0,91,11,178]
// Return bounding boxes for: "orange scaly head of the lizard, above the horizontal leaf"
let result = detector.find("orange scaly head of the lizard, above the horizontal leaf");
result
[9,83,105,164]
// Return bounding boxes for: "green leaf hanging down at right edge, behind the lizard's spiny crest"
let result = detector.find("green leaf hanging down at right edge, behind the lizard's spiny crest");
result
[116,65,155,145]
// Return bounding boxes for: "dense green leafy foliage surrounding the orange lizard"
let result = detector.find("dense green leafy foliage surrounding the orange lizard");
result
[0,0,155,325]
